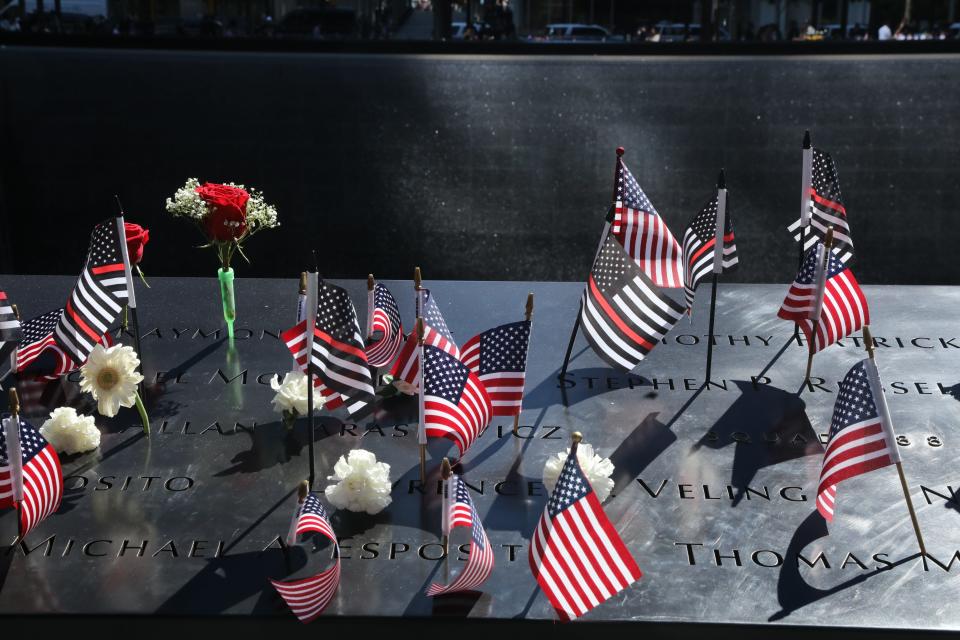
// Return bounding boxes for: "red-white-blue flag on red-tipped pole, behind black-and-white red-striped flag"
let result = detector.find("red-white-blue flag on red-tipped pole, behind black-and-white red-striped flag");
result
[611,157,683,288]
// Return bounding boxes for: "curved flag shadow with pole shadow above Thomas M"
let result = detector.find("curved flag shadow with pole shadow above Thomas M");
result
[767,511,921,622]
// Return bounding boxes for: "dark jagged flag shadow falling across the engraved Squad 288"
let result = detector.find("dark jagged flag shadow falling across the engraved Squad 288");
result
[691,380,823,507]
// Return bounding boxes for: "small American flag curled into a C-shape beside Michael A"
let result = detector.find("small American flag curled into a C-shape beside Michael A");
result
[270,493,340,623]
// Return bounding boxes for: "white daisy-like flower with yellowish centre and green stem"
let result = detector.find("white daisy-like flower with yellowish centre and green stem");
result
[80,344,143,418]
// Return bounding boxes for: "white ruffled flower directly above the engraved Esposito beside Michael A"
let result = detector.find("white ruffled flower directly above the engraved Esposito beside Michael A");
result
[324,449,393,515]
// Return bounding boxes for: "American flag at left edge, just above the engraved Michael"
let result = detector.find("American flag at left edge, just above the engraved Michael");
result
[0,414,63,536]
